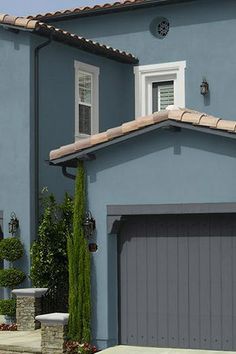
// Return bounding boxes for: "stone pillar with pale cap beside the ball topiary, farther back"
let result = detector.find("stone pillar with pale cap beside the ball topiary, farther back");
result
[12,288,47,331]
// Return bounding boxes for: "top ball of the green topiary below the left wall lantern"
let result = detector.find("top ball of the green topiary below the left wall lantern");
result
[0,237,24,262]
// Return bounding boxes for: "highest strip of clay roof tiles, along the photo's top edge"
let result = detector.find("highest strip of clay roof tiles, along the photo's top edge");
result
[28,0,148,20]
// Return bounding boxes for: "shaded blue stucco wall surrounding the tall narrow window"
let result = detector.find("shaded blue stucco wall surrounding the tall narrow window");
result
[33,38,134,198]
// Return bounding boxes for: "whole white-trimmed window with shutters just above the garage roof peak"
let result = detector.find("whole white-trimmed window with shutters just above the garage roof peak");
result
[134,61,186,117]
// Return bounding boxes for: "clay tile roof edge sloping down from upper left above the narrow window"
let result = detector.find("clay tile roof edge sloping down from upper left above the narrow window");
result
[0,14,138,64]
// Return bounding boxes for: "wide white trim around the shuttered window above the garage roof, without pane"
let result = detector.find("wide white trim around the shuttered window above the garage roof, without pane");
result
[134,61,186,118]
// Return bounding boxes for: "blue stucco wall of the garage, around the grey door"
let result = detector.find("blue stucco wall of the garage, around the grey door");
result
[86,130,236,347]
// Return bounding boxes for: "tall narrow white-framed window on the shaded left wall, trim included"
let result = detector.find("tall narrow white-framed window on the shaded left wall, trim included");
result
[75,61,99,139]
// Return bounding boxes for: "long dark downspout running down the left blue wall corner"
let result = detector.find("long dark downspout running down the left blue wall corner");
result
[34,35,52,230]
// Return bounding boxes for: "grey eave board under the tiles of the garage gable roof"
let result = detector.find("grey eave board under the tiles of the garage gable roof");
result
[49,119,236,168]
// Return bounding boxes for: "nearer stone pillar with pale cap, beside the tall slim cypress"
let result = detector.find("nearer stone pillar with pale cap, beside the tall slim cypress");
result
[36,313,69,354]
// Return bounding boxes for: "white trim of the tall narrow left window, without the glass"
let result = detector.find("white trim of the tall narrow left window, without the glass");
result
[74,60,100,140]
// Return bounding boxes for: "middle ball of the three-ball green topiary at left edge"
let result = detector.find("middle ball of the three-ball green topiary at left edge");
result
[0,268,26,289]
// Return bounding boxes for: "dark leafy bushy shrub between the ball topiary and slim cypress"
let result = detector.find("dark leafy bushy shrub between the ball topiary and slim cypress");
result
[30,189,74,290]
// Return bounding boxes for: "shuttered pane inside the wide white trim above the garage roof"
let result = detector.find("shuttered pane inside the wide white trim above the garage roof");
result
[152,81,174,112]
